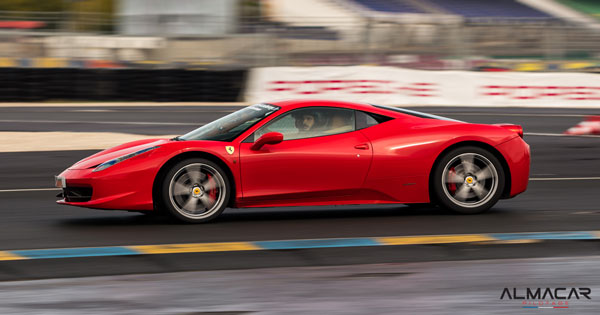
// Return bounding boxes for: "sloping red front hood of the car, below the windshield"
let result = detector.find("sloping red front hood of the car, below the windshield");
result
[69,139,169,170]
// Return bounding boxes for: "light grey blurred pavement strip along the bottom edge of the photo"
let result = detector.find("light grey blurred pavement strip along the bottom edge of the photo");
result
[0,256,600,315]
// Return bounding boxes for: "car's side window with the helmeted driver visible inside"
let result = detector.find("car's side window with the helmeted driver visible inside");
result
[254,107,356,140]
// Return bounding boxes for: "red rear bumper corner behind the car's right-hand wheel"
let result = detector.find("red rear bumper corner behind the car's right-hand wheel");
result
[497,137,531,198]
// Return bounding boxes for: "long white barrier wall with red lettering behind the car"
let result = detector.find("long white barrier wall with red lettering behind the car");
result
[245,66,600,107]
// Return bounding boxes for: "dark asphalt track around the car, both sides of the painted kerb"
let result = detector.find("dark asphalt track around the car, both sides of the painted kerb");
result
[0,104,600,279]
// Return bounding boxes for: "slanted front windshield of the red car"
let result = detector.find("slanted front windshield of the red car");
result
[175,104,280,142]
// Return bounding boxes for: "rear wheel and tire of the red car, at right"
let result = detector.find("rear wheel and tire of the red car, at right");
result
[430,146,506,214]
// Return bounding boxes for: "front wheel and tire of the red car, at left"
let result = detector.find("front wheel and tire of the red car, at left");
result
[159,158,231,223]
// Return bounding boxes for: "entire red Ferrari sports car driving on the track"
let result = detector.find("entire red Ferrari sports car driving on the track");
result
[56,100,530,222]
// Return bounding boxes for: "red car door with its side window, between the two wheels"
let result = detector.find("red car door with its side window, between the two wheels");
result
[240,107,372,204]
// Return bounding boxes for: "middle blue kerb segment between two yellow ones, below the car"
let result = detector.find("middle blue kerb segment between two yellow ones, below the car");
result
[253,238,382,249]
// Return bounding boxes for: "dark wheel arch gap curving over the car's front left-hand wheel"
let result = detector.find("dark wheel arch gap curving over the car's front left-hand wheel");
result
[152,151,236,211]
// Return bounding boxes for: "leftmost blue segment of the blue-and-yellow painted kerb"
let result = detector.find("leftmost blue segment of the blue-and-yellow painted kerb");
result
[10,246,141,259]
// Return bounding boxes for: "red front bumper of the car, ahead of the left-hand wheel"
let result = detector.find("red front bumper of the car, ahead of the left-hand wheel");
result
[56,169,154,210]
